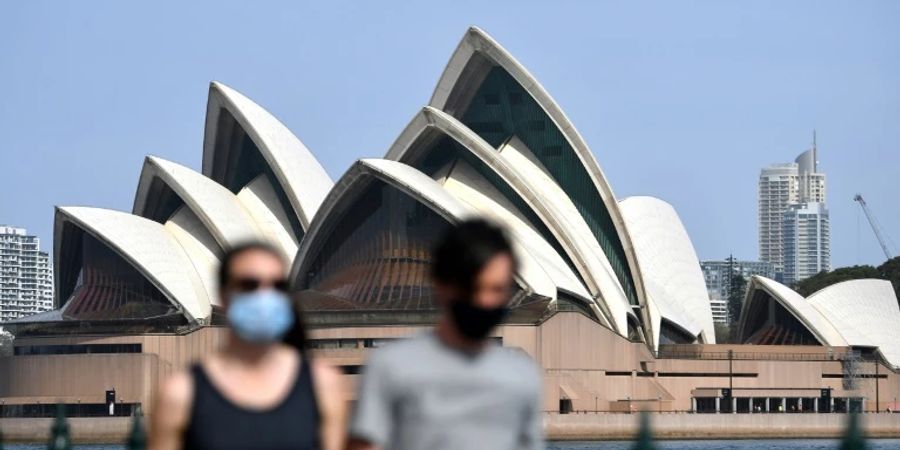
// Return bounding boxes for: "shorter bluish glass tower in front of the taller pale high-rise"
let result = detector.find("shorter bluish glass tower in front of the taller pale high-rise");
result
[782,203,831,285]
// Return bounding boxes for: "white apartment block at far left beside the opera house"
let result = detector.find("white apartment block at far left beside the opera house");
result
[0,225,53,322]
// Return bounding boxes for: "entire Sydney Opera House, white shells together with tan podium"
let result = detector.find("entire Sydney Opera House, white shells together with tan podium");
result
[0,28,900,417]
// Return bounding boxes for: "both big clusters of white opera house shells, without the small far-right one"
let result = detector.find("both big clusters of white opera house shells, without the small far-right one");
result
[1,28,715,349]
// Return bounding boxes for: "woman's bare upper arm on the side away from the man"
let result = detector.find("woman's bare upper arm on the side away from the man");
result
[147,372,194,450]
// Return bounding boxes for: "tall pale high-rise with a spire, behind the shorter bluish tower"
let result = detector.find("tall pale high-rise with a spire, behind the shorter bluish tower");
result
[757,134,830,281]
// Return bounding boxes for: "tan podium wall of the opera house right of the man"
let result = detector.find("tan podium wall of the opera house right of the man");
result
[538,313,900,411]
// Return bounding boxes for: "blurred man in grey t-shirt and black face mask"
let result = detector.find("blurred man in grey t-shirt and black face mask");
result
[350,220,544,450]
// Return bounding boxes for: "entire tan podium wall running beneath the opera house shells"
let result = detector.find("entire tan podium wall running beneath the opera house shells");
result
[0,312,900,417]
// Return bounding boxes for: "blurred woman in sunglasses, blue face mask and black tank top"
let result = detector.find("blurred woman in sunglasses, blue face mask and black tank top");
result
[149,243,346,450]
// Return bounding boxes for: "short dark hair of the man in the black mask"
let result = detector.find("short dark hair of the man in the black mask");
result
[431,219,517,294]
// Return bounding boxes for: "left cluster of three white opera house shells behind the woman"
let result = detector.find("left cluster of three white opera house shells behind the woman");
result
[8,83,333,333]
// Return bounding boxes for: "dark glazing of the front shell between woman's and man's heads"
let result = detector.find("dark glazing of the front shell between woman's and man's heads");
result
[303,181,449,310]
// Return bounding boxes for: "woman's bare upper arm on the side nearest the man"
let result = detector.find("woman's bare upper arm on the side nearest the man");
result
[311,358,348,450]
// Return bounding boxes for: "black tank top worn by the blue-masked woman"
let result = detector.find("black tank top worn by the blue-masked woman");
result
[184,359,319,450]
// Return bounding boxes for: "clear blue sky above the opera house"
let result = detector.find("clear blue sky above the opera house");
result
[0,0,900,266]
